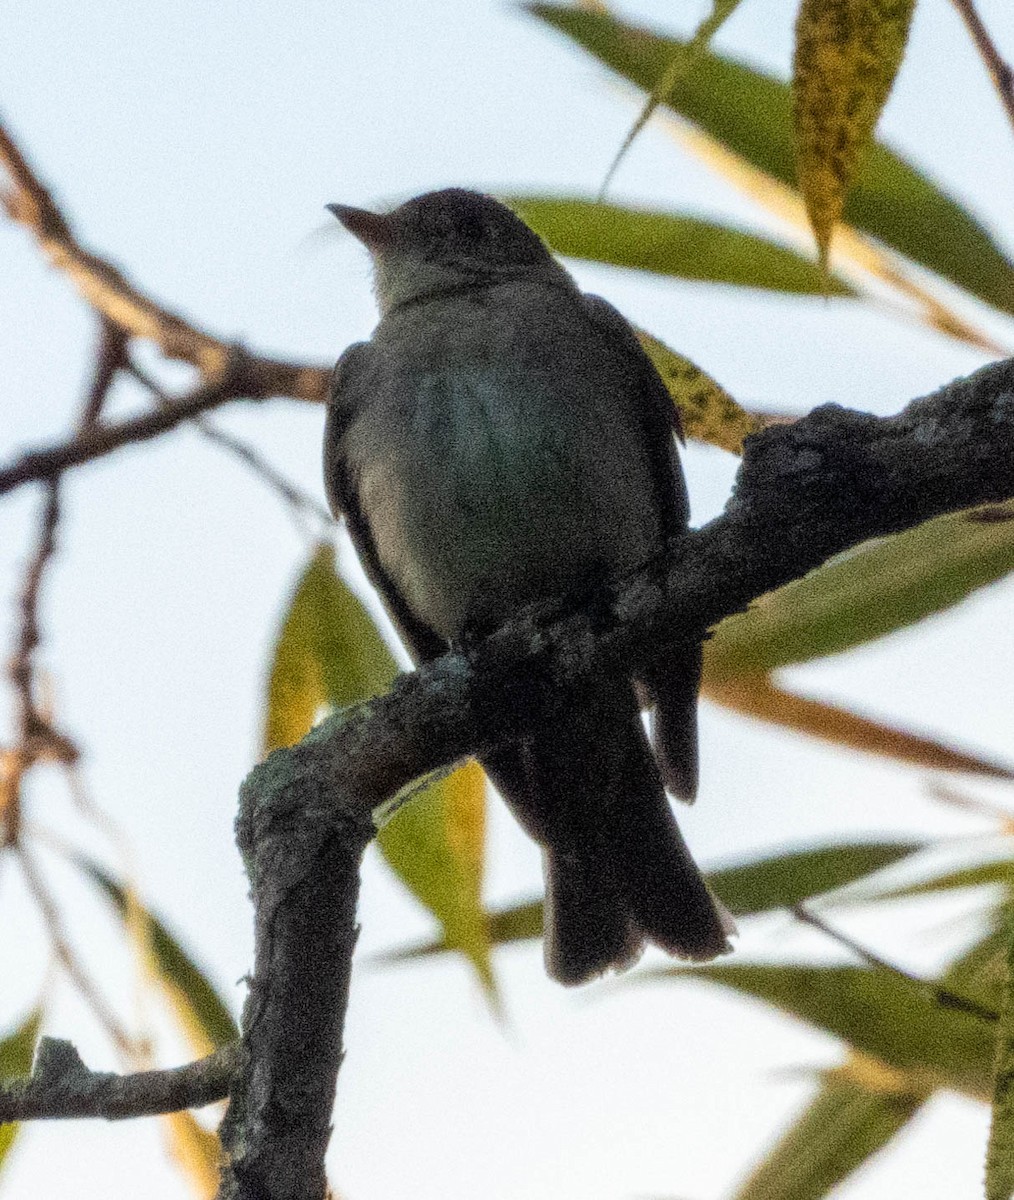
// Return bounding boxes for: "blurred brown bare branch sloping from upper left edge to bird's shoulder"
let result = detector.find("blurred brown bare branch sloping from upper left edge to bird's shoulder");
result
[0,125,330,403]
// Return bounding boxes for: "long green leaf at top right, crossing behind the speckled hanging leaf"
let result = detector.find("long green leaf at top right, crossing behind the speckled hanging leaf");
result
[530,4,1014,313]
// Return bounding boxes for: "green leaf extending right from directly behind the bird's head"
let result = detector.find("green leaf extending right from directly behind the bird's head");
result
[504,196,854,295]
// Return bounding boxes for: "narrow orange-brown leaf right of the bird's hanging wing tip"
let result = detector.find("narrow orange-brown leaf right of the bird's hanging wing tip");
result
[701,672,1014,779]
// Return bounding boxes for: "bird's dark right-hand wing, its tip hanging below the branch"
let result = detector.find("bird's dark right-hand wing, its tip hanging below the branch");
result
[584,295,702,800]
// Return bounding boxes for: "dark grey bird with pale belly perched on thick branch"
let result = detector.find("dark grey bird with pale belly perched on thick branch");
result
[324,188,731,984]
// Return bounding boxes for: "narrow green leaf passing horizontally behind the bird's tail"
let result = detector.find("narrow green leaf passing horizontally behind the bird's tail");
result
[384,841,923,960]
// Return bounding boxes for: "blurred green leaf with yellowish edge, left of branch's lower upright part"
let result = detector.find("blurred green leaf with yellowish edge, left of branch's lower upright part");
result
[74,854,239,1055]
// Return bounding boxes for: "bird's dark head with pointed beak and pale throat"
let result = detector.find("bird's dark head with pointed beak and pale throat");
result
[328,187,566,311]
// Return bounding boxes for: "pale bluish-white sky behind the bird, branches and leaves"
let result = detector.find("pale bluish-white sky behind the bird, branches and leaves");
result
[0,0,1014,1200]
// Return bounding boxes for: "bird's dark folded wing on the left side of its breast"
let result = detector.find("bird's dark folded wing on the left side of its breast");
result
[324,342,448,662]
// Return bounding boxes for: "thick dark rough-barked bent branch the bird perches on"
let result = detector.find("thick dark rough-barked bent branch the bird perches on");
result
[3,360,1014,1200]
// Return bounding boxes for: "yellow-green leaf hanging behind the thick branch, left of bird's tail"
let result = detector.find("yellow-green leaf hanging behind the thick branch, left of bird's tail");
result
[264,545,494,1000]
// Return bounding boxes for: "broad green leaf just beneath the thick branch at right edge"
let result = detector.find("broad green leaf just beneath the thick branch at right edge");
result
[704,503,1014,683]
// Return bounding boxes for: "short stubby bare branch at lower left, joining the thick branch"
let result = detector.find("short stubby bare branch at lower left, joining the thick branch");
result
[0,1038,239,1124]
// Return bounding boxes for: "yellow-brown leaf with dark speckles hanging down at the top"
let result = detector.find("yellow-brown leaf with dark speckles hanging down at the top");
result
[793,0,914,263]
